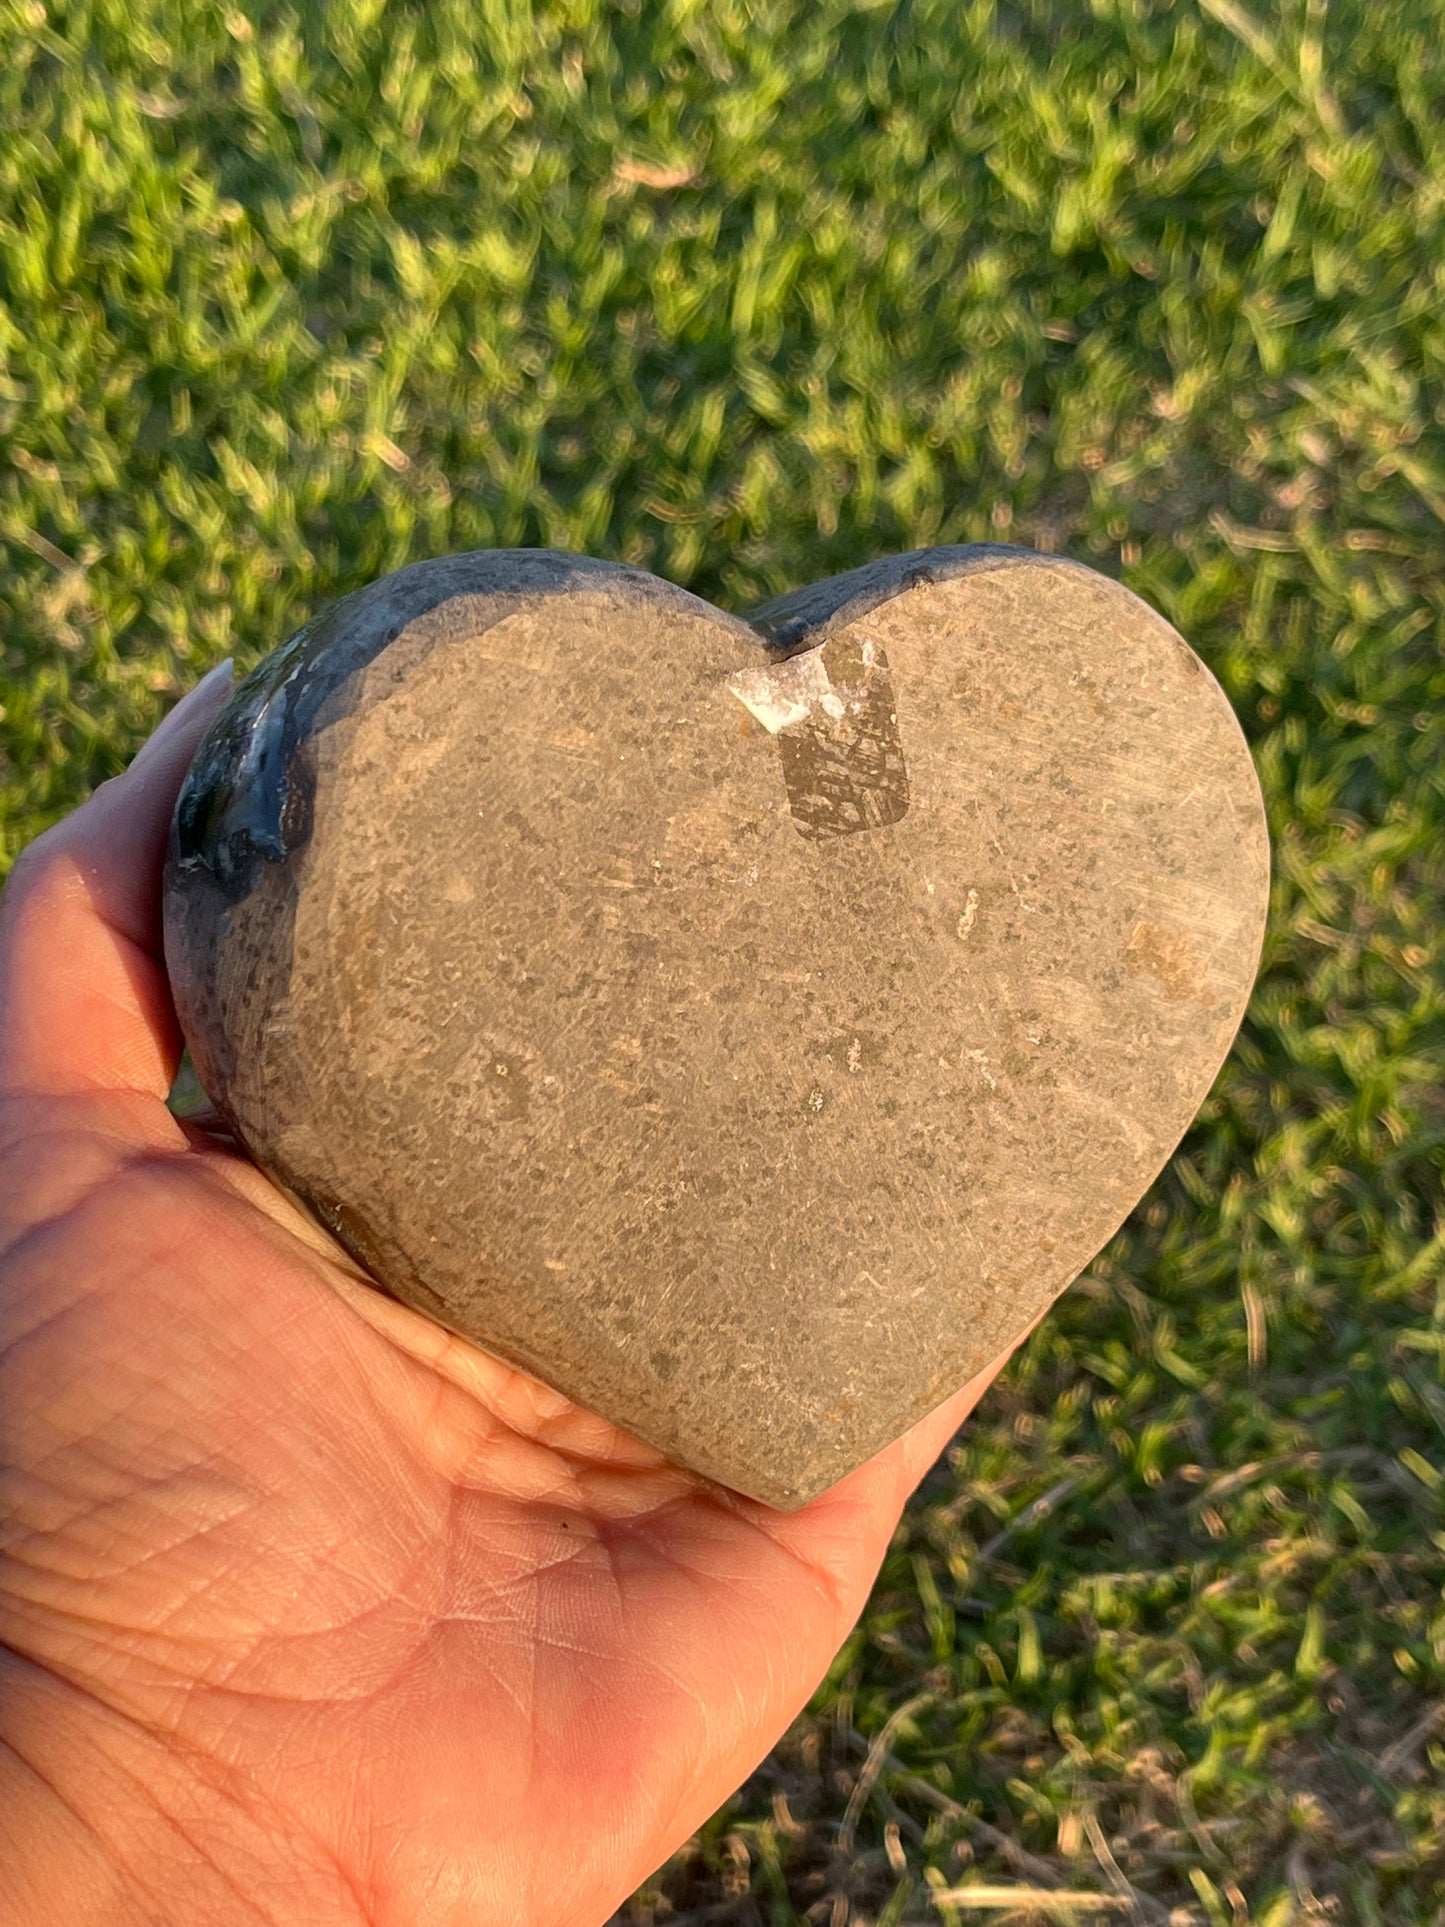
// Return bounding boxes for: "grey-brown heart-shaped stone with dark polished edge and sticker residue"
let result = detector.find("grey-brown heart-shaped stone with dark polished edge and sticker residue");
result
[166,547,1268,1505]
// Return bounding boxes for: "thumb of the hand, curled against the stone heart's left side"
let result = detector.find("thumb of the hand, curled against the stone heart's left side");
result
[0,659,231,1098]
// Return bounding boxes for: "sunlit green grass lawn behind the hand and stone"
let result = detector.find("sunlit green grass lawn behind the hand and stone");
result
[0,0,1445,1927]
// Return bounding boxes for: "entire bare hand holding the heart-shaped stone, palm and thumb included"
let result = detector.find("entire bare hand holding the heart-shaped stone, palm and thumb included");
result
[0,673,1004,1927]
